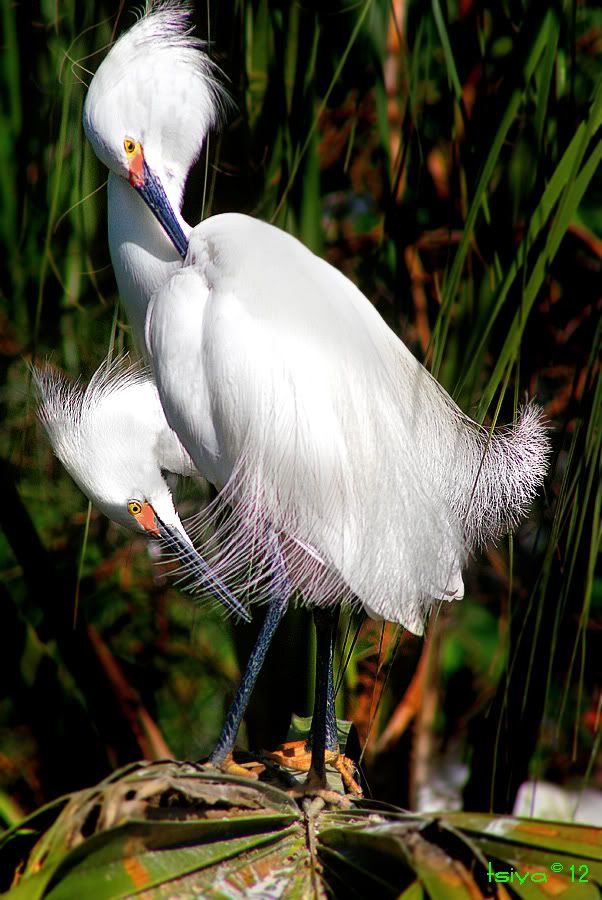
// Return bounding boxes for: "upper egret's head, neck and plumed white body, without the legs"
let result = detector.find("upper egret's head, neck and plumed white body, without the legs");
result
[84,4,548,780]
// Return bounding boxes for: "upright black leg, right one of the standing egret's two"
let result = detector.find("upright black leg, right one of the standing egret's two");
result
[310,607,339,781]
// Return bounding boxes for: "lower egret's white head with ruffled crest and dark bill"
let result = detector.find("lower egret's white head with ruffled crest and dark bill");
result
[33,359,250,621]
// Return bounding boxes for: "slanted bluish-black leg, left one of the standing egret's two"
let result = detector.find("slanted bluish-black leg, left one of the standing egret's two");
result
[209,535,290,766]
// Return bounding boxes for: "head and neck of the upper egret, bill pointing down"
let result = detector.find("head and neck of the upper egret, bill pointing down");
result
[84,3,226,349]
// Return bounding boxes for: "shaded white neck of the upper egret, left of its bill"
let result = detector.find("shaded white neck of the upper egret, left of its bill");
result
[108,172,191,356]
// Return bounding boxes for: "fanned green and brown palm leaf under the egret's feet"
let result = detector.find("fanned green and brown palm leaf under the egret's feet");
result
[0,762,602,900]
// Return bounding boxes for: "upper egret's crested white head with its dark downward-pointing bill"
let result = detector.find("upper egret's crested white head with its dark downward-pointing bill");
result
[83,3,226,255]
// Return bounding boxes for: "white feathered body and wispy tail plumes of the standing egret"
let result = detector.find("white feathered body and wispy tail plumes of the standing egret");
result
[147,214,547,633]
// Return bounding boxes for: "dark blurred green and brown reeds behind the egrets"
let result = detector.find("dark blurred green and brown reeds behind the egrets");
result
[0,0,602,824]
